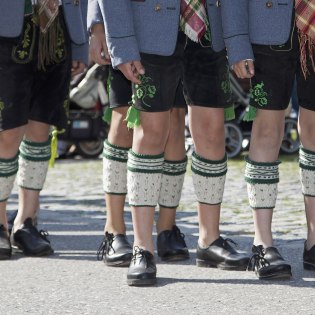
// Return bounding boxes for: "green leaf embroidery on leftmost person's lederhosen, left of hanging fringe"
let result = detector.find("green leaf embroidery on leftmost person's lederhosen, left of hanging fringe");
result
[12,16,36,64]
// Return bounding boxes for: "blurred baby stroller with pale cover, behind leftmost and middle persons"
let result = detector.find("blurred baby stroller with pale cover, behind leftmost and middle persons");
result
[58,65,109,158]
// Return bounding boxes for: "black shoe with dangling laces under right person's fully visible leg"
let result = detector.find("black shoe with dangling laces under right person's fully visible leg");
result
[248,245,292,280]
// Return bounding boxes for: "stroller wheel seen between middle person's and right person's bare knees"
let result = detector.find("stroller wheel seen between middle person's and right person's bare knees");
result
[224,122,243,158]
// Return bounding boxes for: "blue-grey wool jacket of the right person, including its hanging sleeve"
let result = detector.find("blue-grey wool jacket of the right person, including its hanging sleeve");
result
[221,0,294,65]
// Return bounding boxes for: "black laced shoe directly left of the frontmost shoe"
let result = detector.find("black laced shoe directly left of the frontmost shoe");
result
[97,232,132,267]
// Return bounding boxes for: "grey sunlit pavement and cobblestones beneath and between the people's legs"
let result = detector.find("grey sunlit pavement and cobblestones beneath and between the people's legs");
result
[0,157,315,315]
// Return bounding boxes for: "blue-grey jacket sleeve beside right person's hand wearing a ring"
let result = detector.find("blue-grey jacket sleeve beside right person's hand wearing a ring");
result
[221,0,254,66]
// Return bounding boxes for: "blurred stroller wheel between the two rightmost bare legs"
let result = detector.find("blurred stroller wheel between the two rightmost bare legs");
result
[280,117,300,154]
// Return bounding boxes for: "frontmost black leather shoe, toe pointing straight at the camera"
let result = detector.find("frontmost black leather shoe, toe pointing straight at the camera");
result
[127,247,156,286]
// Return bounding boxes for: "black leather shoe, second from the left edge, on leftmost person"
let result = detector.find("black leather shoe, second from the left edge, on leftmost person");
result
[11,218,54,256]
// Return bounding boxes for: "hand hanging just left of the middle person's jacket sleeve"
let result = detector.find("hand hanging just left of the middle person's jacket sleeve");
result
[89,23,110,65]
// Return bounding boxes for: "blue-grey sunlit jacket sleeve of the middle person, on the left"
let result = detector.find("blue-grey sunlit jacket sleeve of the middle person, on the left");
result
[91,0,140,67]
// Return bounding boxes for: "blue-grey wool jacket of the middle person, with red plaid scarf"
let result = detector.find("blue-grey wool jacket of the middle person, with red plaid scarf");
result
[88,0,227,67]
